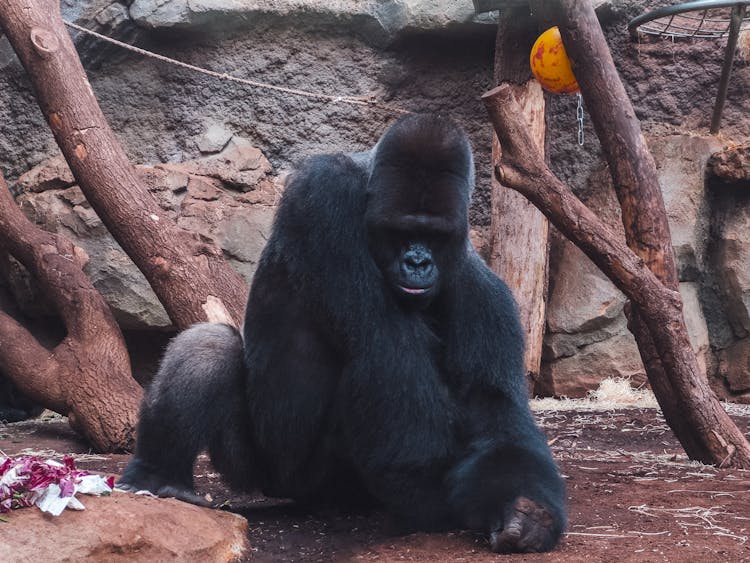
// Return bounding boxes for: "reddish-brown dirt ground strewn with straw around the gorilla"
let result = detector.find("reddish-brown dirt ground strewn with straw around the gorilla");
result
[0,407,750,562]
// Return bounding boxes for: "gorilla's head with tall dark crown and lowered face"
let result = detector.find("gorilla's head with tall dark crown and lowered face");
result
[365,116,474,308]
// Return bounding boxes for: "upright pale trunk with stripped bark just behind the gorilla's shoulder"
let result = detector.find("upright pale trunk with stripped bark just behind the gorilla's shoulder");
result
[489,6,549,392]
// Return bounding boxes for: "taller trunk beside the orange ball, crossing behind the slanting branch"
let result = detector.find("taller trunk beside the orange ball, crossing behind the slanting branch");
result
[536,0,726,468]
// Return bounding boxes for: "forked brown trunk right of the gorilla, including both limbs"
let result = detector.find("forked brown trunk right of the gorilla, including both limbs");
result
[483,13,750,468]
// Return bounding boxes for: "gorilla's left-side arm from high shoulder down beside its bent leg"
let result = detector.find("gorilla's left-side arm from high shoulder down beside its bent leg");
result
[244,155,374,498]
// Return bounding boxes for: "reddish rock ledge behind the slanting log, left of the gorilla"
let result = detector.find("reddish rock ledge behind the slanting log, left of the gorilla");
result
[13,137,280,330]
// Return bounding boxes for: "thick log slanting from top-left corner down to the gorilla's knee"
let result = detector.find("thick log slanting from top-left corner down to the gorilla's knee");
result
[0,0,247,328]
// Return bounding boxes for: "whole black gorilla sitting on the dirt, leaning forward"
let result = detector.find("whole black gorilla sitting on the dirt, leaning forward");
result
[120,116,565,551]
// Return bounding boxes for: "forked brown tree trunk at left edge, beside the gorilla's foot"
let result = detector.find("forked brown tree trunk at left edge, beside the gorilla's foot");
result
[0,176,143,451]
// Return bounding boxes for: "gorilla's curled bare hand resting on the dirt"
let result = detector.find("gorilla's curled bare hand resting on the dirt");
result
[490,497,560,553]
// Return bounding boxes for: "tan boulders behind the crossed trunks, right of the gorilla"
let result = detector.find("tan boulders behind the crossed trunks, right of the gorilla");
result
[535,135,720,397]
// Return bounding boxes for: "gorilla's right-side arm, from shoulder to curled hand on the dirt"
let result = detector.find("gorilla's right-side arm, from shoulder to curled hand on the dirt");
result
[446,250,565,551]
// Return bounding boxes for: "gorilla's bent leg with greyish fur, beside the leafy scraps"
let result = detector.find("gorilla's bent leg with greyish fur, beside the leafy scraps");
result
[118,323,253,504]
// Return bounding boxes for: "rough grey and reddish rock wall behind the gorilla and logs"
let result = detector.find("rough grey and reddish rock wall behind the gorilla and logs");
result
[0,0,750,400]
